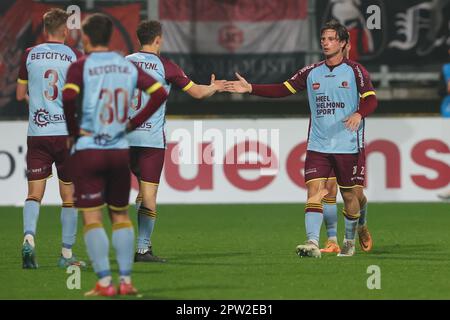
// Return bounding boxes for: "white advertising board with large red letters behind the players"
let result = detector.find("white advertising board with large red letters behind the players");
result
[0,117,450,206]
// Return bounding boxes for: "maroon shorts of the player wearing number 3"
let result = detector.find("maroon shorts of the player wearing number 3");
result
[27,136,72,183]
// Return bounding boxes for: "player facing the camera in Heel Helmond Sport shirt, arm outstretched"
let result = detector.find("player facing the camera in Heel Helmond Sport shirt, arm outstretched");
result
[225,20,378,257]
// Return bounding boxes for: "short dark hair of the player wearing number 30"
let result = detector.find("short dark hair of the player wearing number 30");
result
[81,13,113,46]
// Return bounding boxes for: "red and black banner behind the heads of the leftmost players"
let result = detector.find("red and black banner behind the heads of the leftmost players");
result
[0,0,141,118]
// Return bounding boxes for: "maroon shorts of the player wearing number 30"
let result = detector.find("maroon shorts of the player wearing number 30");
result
[72,149,131,211]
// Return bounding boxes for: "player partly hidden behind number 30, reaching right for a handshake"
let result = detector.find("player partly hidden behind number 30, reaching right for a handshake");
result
[126,21,225,262]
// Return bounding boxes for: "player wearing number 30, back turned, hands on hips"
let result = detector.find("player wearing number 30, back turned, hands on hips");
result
[63,14,167,296]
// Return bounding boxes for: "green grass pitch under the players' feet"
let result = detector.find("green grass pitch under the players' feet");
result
[0,203,450,300]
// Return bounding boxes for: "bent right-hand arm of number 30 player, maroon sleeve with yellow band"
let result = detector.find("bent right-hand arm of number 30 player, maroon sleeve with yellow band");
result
[127,67,167,132]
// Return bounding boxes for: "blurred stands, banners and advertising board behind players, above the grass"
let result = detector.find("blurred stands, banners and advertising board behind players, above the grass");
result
[0,0,450,205]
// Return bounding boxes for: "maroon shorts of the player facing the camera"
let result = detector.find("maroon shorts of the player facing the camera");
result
[305,149,366,188]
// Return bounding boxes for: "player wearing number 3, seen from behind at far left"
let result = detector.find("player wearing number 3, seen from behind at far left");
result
[16,9,85,269]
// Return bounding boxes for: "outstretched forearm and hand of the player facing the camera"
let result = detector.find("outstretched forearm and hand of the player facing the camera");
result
[225,72,306,98]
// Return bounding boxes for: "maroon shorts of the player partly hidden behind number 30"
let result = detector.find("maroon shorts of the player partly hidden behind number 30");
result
[130,147,166,185]
